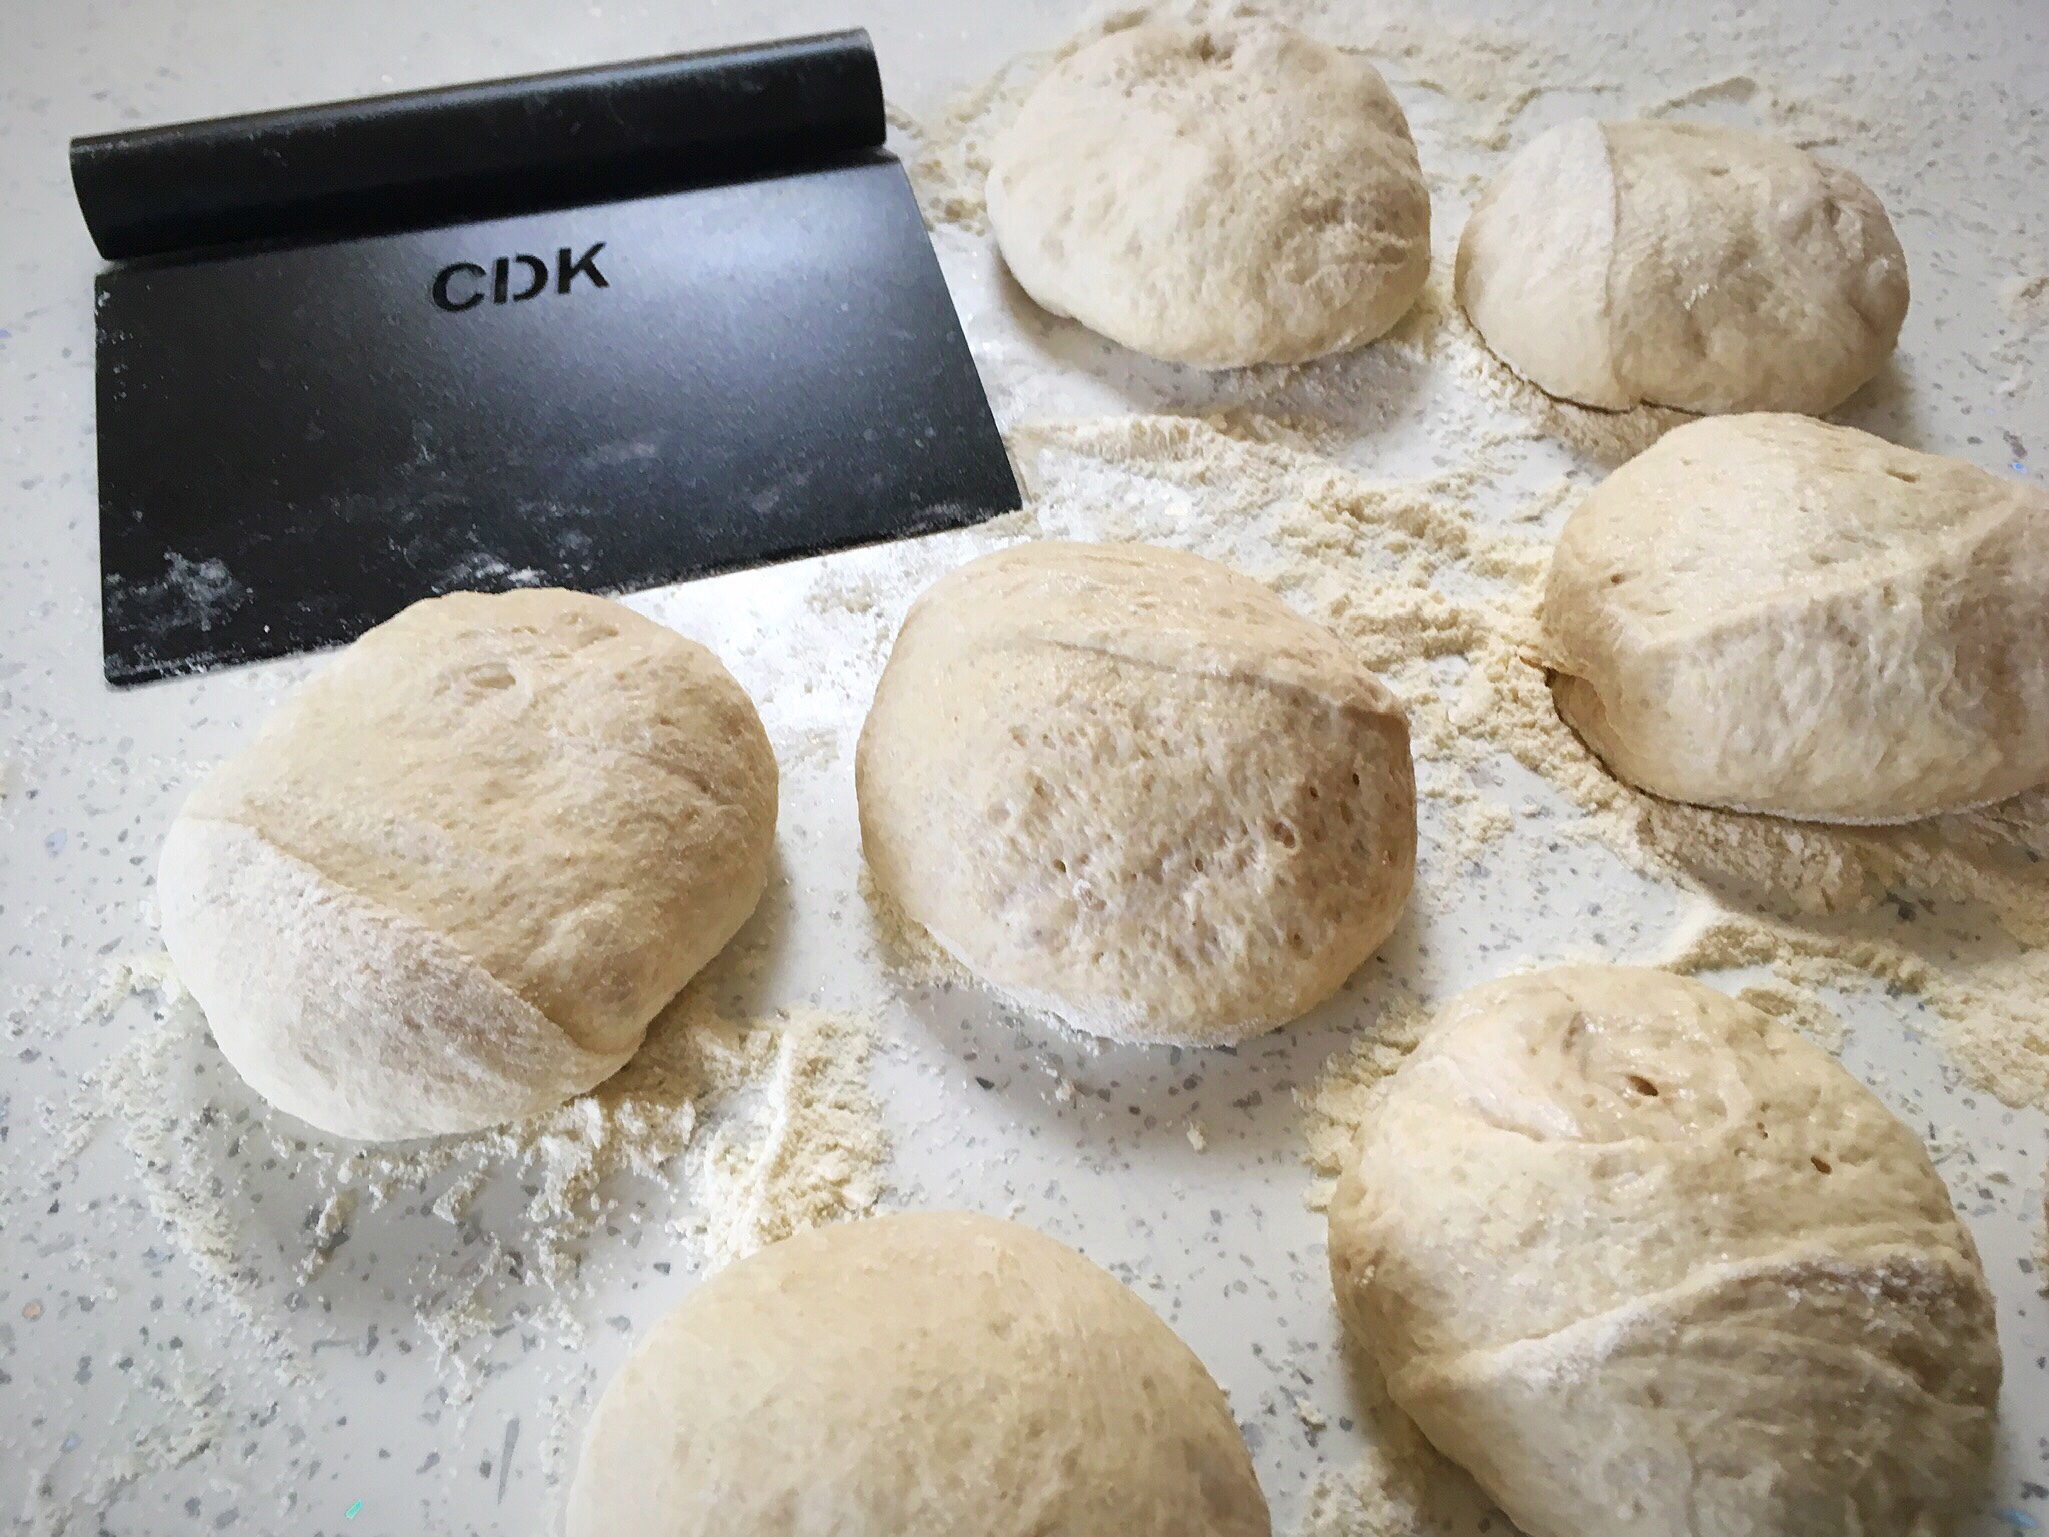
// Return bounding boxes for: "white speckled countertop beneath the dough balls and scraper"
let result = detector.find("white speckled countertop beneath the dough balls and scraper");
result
[0,0,2049,1537]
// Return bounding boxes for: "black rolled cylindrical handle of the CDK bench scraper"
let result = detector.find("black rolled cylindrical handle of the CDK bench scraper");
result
[72,31,887,260]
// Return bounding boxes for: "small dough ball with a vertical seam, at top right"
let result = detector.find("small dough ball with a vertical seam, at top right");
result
[1457,119,1908,414]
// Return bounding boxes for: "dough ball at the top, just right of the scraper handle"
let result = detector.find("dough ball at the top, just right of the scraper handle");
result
[988,20,1430,369]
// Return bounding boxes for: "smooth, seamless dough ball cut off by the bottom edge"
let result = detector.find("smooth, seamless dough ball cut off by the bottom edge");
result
[568,1211,1268,1537]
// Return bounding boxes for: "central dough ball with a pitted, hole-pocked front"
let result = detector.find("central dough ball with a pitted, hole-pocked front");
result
[854,543,1416,1045]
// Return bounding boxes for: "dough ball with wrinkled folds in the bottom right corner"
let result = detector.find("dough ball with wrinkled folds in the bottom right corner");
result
[1330,965,2000,1537]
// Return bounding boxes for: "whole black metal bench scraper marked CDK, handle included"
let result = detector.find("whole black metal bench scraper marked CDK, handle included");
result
[72,33,1018,684]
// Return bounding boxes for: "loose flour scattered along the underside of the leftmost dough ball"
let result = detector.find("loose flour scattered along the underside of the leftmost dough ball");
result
[64,953,889,1398]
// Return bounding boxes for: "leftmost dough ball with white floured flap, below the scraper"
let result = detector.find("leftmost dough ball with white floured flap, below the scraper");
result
[158,590,777,1139]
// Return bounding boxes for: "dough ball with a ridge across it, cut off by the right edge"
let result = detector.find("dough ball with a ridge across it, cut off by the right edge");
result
[1543,405,2049,822]
